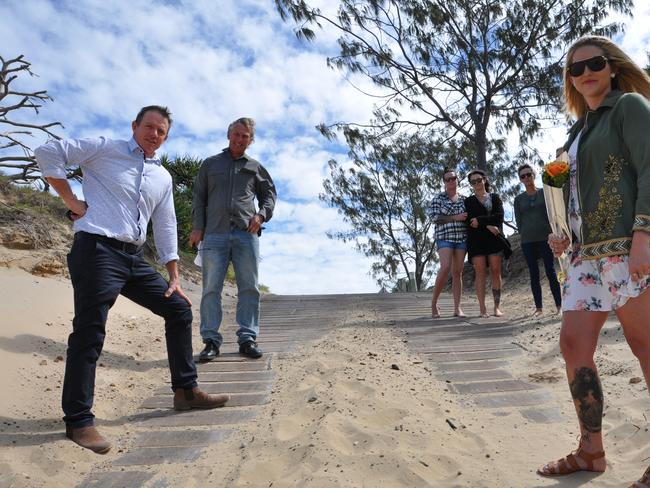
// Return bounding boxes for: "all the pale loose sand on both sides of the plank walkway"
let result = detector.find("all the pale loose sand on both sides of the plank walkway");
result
[0,258,650,488]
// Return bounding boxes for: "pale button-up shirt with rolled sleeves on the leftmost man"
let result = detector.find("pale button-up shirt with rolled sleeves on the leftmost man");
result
[34,137,178,264]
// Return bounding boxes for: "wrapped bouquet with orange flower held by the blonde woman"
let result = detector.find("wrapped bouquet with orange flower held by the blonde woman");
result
[542,152,571,283]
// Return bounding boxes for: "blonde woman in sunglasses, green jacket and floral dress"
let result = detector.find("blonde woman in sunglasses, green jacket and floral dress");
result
[537,36,650,488]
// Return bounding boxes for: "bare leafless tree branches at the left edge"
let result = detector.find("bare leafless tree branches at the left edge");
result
[0,55,67,188]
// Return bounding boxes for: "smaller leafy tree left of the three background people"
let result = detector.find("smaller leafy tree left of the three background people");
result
[320,133,463,289]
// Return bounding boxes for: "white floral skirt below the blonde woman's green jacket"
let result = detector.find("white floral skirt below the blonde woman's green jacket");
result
[562,252,650,312]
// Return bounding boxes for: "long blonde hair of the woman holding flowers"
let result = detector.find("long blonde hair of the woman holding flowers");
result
[563,36,650,118]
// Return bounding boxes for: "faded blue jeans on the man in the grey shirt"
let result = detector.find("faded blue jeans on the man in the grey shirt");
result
[200,229,260,346]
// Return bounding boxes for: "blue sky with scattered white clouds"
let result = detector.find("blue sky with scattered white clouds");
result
[0,0,650,294]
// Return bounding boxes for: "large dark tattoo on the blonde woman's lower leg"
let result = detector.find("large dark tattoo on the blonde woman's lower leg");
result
[570,367,603,432]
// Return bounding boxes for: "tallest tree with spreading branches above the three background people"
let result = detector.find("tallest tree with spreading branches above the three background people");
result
[275,0,633,174]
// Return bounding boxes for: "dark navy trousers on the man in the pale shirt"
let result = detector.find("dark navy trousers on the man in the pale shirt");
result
[62,232,197,428]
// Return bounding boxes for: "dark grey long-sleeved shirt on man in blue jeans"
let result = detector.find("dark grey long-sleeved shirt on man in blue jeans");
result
[192,149,277,234]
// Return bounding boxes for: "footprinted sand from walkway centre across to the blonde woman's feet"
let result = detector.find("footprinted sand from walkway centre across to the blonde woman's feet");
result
[205,292,650,488]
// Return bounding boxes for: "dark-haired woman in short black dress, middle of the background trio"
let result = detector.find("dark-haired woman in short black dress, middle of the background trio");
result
[465,169,506,317]
